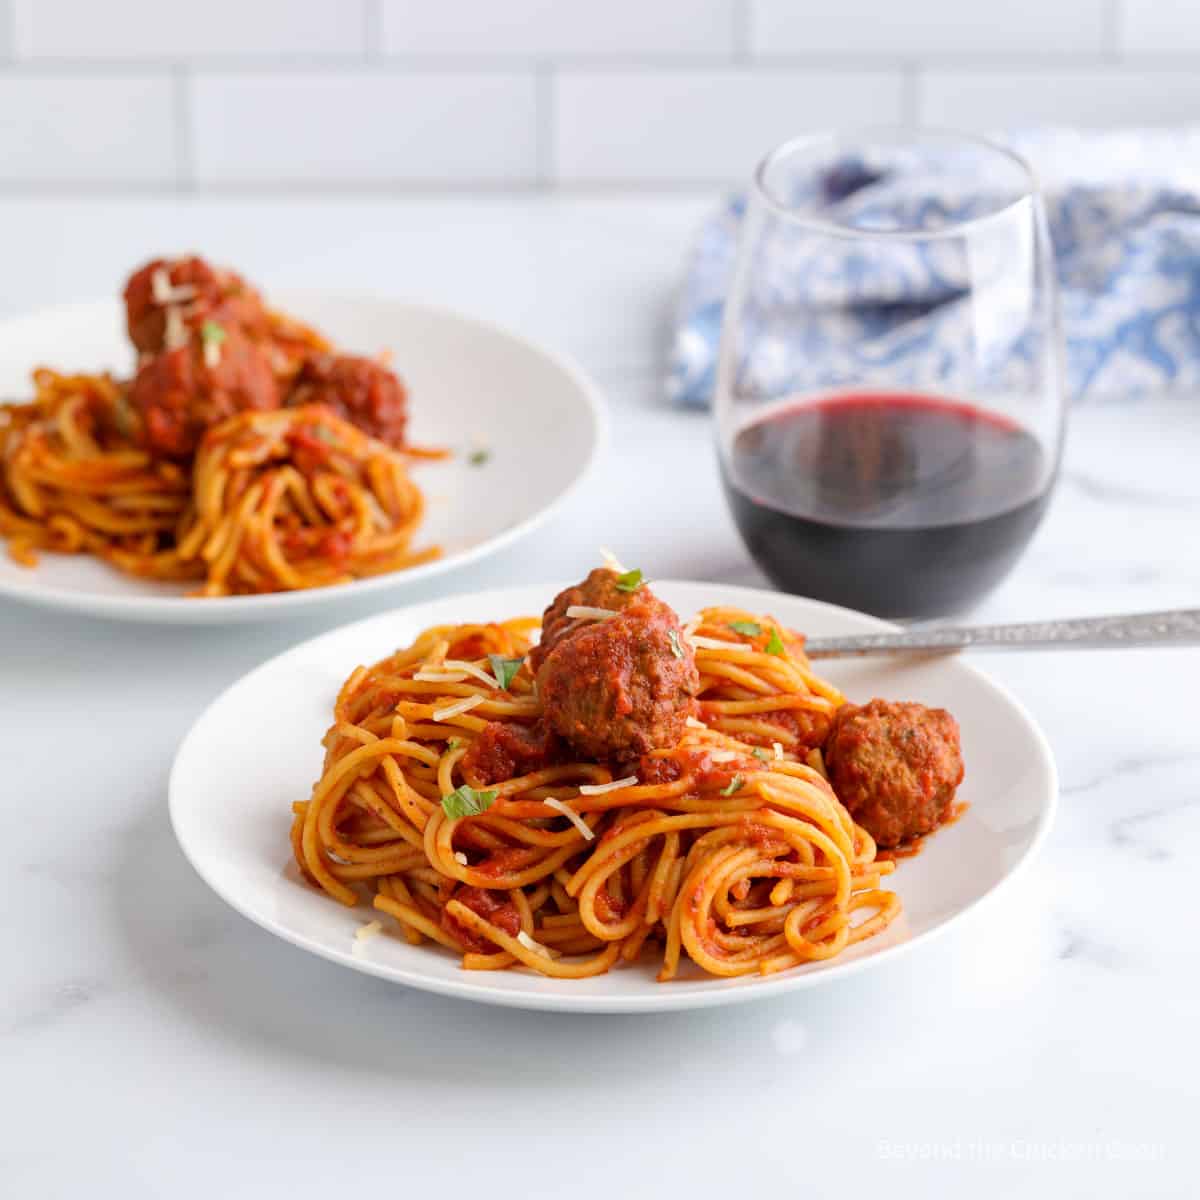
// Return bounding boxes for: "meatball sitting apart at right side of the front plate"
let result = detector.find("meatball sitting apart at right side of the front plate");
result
[824,700,962,848]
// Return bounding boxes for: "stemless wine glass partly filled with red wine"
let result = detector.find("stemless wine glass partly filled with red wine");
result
[715,130,1064,618]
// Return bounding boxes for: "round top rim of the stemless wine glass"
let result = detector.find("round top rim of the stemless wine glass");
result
[754,125,1042,241]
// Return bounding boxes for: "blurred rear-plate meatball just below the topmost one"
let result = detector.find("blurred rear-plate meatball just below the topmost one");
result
[130,329,280,458]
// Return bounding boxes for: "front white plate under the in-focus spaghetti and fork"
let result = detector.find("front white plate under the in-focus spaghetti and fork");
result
[170,582,1058,1013]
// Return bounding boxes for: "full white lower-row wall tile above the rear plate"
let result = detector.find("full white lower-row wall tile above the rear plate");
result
[192,70,536,188]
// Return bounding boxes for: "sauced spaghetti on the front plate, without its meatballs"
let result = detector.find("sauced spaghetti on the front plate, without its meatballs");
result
[292,585,900,980]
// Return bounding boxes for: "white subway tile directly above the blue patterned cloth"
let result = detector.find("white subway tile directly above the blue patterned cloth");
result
[918,67,1200,130]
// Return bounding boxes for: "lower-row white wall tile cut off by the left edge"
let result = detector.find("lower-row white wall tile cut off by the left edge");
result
[0,72,176,184]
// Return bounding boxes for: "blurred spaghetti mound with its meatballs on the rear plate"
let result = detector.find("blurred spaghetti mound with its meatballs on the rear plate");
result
[0,259,439,596]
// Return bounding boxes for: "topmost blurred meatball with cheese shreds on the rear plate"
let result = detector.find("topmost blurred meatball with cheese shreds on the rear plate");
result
[125,256,268,354]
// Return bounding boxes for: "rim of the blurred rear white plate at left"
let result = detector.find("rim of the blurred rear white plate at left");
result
[0,294,611,625]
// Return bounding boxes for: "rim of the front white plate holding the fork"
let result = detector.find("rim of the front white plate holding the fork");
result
[167,578,1060,1014]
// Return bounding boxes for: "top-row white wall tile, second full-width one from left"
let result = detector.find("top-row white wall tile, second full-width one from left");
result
[383,0,742,58]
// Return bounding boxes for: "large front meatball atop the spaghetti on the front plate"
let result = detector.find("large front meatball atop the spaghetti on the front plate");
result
[538,590,700,762]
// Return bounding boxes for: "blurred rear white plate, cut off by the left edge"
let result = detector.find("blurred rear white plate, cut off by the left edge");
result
[0,292,605,624]
